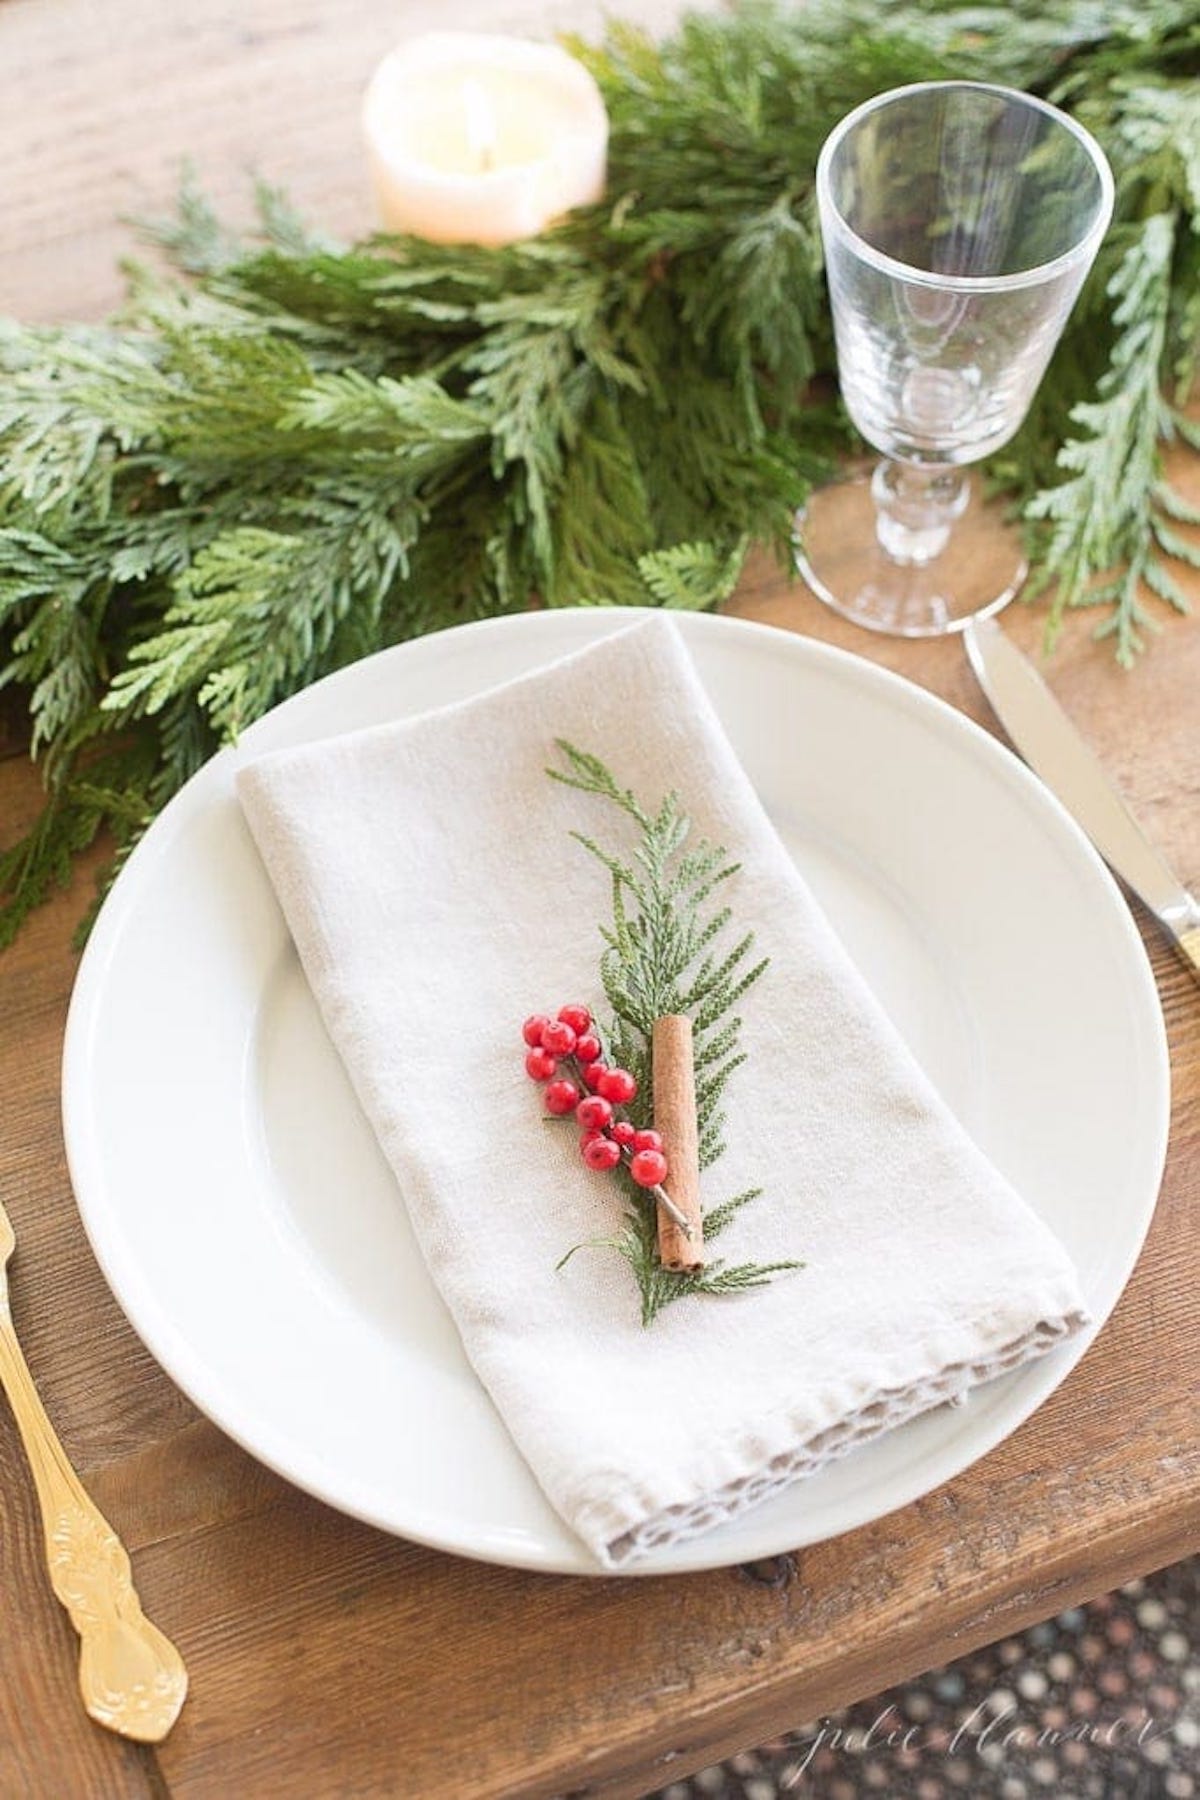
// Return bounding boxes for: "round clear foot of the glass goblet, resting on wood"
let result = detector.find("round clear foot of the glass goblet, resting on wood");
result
[795,473,1029,637]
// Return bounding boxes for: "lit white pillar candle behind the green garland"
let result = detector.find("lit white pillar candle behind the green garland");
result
[363,31,608,245]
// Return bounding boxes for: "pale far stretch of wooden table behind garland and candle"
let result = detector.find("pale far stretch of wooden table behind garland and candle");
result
[0,0,698,320]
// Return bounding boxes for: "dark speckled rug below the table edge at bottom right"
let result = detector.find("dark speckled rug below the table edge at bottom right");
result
[649,1561,1200,1800]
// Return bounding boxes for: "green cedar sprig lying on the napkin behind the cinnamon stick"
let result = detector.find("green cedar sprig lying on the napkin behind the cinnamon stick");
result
[547,738,802,1325]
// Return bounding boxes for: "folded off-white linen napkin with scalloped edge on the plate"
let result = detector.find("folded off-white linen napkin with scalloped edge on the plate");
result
[237,617,1087,1568]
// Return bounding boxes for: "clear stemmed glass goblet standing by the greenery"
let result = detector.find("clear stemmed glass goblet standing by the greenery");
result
[797,81,1114,637]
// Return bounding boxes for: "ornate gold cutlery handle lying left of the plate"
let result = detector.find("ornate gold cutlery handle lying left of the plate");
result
[0,1204,187,1744]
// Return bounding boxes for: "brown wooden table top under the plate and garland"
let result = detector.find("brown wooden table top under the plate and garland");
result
[0,0,1200,1800]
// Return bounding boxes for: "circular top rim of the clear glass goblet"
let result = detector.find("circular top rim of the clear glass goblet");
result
[817,79,1115,293]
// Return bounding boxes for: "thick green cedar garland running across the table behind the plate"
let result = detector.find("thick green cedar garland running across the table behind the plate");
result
[0,0,1200,941]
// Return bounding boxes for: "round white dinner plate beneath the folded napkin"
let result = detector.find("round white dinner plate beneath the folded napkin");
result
[63,608,1169,1573]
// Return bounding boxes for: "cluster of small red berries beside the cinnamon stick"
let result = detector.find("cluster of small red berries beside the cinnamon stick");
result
[522,1006,667,1188]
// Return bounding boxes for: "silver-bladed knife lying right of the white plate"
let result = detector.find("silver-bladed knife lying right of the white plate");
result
[963,619,1200,981]
